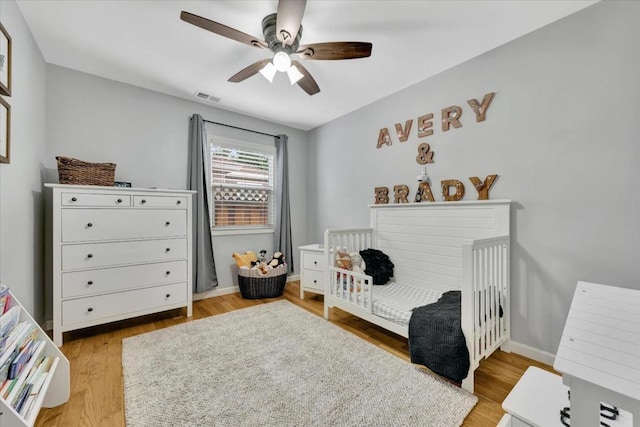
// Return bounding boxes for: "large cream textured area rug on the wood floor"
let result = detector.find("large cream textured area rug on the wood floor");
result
[122,301,477,427]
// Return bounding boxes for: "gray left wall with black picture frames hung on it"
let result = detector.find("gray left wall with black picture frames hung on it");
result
[0,1,46,322]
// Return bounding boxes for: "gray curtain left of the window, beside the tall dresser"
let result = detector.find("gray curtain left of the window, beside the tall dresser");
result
[189,114,218,293]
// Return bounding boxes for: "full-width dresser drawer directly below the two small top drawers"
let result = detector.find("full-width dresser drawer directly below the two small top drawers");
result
[61,209,187,243]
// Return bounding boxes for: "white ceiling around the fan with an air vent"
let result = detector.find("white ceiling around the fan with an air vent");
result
[18,0,595,130]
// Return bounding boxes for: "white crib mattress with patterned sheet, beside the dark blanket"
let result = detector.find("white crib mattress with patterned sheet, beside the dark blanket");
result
[373,282,442,326]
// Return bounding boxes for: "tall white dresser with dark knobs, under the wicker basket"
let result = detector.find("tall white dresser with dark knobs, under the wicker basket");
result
[45,184,194,346]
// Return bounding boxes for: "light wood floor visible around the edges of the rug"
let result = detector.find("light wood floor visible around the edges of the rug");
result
[36,282,551,427]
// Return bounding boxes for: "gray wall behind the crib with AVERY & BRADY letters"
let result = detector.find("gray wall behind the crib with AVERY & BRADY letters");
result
[308,1,640,353]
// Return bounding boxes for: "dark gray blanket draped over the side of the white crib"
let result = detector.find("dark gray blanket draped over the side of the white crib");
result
[409,291,469,384]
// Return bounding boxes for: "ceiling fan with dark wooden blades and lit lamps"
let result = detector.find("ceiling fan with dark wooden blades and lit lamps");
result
[180,0,372,95]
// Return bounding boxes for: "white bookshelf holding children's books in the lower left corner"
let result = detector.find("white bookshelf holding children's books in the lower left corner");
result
[0,295,70,427]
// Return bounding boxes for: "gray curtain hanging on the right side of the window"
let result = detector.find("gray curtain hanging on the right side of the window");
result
[273,135,294,274]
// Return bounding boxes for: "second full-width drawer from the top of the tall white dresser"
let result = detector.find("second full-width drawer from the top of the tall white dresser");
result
[62,239,187,271]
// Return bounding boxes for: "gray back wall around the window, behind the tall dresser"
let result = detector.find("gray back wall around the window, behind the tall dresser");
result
[45,64,308,318]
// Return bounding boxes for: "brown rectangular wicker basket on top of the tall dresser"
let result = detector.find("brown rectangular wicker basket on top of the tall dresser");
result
[56,157,116,187]
